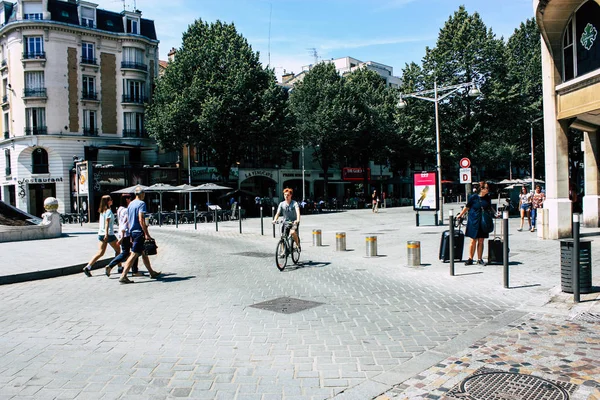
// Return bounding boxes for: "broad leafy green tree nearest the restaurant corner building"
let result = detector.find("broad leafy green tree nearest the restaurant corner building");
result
[146,20,291,179]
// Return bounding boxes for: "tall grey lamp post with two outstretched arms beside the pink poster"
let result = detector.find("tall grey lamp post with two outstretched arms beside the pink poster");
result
[398,80,481,225]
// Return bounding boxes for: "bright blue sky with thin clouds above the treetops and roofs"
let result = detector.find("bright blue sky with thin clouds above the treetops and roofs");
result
[90,0,533,77]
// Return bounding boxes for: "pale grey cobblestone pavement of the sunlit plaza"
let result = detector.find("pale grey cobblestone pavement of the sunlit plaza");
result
[0,209,600,400]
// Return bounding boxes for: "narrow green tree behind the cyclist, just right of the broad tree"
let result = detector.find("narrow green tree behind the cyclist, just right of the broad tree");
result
[290,63,349,199]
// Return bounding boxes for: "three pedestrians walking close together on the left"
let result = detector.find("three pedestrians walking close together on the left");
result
[83,186,161,284]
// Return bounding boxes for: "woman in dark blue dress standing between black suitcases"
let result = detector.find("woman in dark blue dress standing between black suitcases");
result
[458,181,492,265]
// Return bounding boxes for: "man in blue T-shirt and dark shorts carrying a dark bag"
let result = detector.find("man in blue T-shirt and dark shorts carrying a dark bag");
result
[119,186,161,283]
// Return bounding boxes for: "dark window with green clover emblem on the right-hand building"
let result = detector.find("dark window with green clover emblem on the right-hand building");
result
[562,0,600,81]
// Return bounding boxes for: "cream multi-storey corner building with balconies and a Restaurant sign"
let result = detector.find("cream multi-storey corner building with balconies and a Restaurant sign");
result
[0,0,163,215]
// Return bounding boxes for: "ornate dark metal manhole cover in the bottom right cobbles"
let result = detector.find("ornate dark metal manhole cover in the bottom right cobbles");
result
[444,368,577,400]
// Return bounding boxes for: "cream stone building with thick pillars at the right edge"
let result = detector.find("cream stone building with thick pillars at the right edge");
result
[533,0,600,239]
